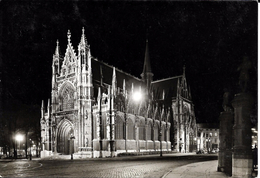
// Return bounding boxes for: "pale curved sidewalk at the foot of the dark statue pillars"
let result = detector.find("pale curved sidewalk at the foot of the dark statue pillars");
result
[163,160,228,178]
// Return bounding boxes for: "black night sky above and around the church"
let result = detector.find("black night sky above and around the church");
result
[0,1,257,122]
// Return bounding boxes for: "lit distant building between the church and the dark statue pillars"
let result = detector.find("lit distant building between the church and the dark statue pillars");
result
[197,123,219,153]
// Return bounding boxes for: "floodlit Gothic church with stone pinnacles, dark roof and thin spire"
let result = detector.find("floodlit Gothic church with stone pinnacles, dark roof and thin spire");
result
[40,28,196,158]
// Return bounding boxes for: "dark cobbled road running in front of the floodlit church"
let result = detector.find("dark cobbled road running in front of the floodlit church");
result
[0,155,217,177]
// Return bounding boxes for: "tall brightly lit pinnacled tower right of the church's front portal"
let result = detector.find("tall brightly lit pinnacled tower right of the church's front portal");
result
[77,27,93,147]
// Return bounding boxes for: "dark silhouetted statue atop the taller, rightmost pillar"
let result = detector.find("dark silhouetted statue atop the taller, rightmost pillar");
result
[237,57,251,92]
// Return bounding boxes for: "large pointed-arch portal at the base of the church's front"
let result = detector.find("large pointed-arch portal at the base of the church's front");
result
[56,119,74,155]
